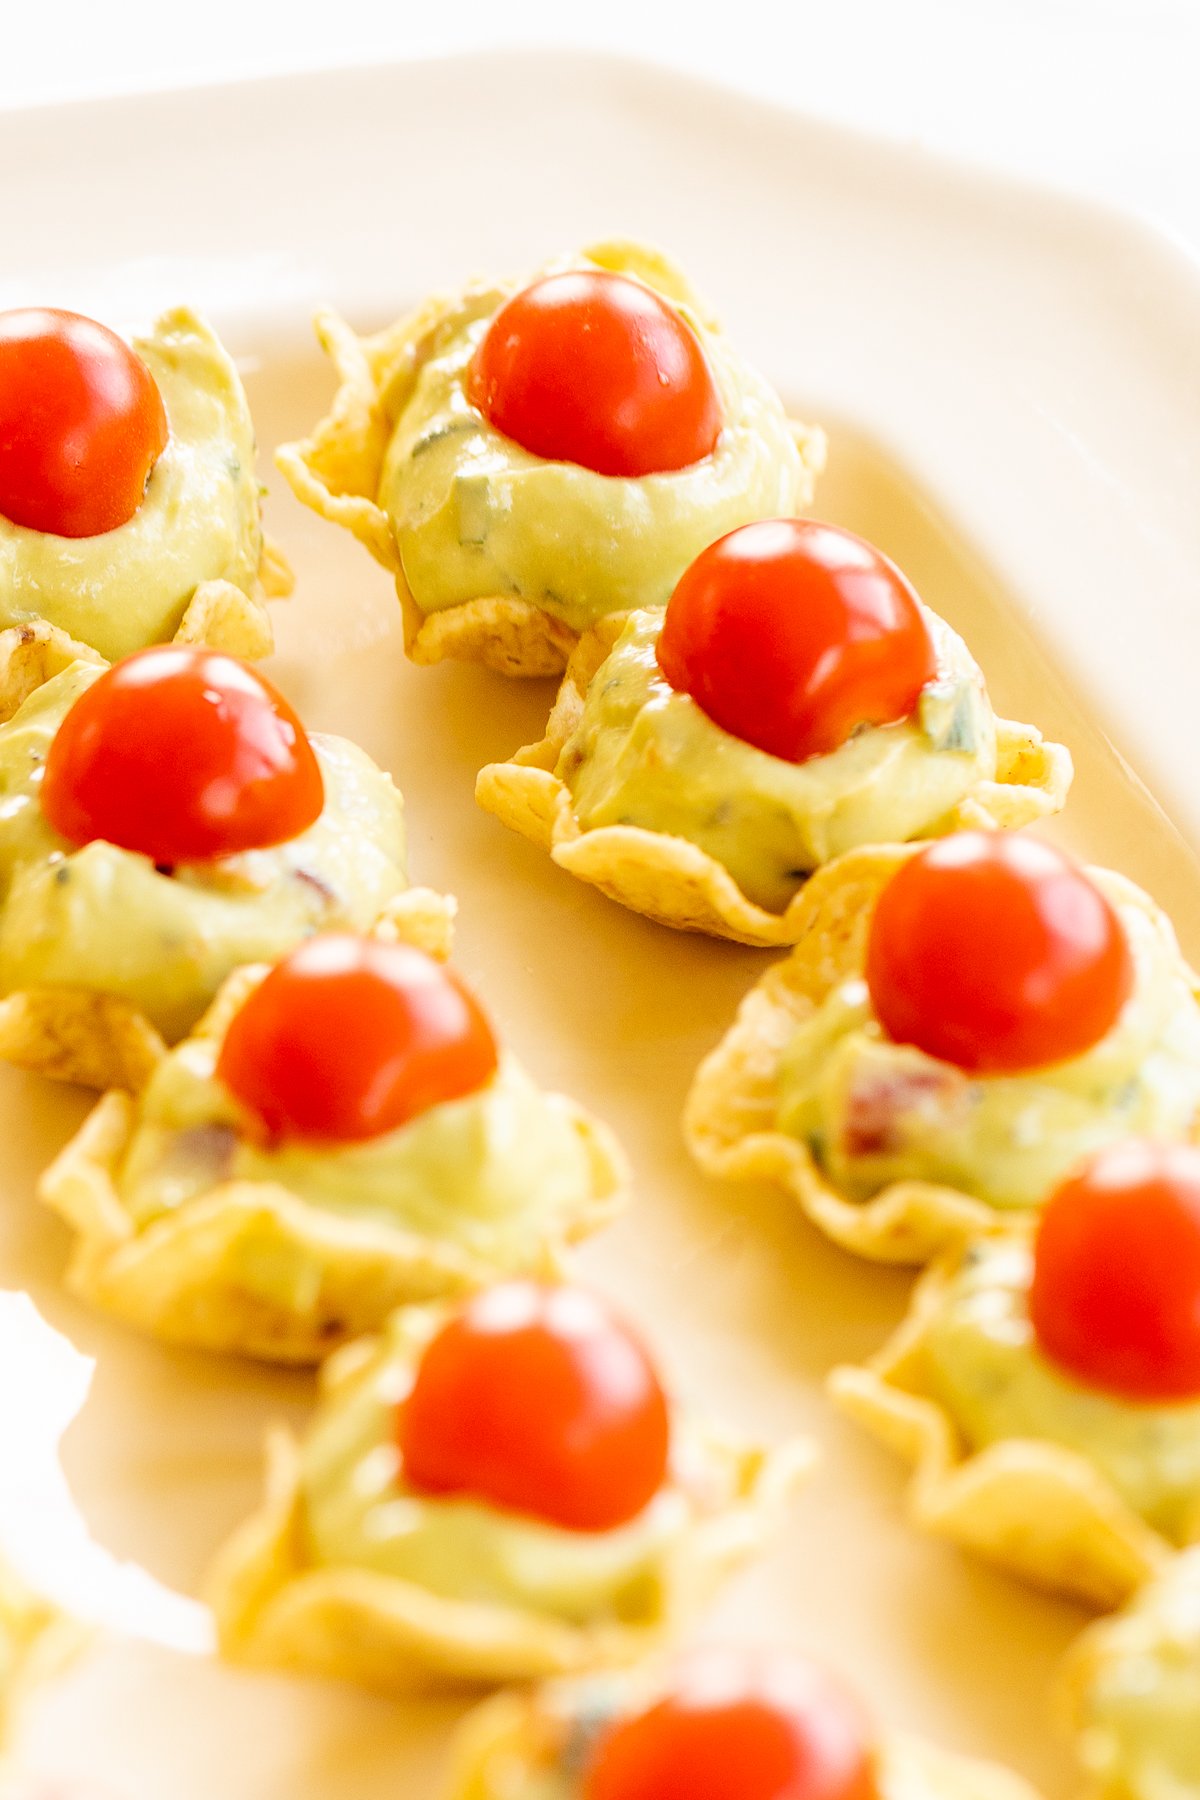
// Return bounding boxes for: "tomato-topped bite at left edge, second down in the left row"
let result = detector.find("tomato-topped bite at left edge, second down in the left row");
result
[0,625,452,1089]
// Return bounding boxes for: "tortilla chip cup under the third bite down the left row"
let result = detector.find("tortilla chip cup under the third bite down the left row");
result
[38,968,628,1363]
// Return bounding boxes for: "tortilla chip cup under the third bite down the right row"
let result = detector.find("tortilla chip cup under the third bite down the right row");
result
[684,844,1200,1264]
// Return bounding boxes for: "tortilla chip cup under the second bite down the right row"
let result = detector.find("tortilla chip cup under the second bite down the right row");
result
[475,614,1072,949]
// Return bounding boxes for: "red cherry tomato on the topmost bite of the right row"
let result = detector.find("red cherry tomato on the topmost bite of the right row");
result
[468,268,721,475]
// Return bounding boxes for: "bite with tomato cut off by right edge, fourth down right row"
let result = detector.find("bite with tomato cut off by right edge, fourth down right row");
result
[831,1139,1200,1606]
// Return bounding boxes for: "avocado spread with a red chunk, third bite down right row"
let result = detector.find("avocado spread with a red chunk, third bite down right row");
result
[779,871,1200,1208]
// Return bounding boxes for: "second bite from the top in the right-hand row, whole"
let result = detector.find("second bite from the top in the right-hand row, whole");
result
[475,518,1070,945]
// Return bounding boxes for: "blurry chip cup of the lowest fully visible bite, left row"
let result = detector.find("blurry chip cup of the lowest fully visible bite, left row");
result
[209,1404,811,1696]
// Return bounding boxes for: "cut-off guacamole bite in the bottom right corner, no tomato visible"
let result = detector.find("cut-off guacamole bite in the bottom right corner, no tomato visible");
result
[1065,1550,1200,1800]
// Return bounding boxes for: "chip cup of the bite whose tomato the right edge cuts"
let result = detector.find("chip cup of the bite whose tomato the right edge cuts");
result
[829,1249,1173,1609]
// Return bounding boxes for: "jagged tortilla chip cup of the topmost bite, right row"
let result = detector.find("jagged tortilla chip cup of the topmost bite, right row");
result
[275,241,826,677]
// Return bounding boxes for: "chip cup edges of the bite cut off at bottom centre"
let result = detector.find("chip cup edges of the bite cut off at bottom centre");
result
[444,1681,1036,1800]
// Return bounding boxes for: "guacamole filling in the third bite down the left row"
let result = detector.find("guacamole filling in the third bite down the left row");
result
[117,1037,592,1273]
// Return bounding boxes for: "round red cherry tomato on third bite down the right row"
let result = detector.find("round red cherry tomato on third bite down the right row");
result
[867,832,1133,1075]
